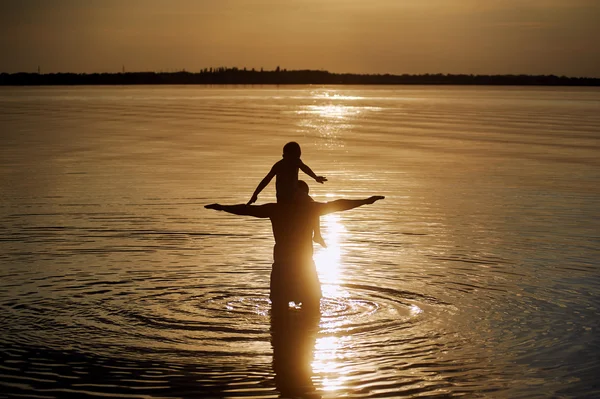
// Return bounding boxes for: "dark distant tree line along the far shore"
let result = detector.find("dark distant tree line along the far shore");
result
[0,67,600,86]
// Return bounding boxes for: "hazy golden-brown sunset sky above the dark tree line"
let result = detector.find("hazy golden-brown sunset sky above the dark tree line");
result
[0,0,600,77]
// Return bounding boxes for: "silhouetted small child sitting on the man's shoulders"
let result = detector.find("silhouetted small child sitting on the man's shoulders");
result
[246,141,327,247]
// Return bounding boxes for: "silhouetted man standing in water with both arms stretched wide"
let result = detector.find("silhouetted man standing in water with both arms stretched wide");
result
[205,181,384,311]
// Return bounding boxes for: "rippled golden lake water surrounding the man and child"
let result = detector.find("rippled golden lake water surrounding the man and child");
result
[0,86,600,398]
